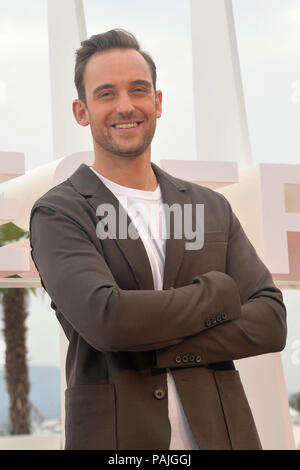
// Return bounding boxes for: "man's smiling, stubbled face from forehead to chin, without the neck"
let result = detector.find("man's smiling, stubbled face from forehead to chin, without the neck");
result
[77,49,162,157]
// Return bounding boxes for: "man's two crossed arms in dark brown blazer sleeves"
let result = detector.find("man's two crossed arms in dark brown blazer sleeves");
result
[30,199,286,367]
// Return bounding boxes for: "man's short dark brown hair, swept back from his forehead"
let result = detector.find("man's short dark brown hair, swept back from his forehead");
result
[74,29,156,104]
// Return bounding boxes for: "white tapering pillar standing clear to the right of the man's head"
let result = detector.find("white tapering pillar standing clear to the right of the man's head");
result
[190,0,252,166]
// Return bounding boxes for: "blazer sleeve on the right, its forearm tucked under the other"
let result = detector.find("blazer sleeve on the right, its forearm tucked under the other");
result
[155,201,287,368]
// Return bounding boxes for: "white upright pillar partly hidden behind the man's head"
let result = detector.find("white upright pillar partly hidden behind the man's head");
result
[48,0,92,159]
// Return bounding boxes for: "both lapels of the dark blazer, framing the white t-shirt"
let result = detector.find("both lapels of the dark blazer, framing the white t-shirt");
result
[68,162,191,290]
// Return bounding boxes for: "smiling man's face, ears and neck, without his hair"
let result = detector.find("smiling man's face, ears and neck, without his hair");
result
[73,36,162,191]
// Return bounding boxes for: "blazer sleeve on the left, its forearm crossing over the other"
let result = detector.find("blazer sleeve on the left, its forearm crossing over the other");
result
[30,203,241,352]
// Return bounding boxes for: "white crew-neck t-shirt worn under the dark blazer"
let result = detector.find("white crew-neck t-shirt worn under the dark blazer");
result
[90,167,199,450]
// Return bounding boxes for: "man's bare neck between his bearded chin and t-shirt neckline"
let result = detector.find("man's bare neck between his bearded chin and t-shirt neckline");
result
[92,149,158,191]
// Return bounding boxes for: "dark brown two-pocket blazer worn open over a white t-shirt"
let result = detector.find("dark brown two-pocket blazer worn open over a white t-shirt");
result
[30,163,286,450]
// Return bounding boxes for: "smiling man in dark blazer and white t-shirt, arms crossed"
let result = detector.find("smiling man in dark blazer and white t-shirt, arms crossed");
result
[30,30,286,450]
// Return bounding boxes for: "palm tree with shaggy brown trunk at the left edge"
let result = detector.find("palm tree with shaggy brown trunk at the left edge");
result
[0,222,43,435]
